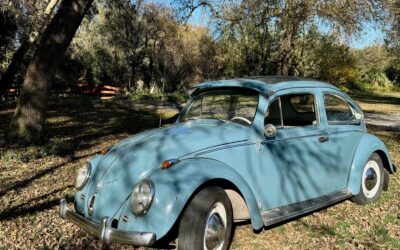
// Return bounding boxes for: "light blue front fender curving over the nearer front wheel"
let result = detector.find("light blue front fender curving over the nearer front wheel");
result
[119,158,263,239]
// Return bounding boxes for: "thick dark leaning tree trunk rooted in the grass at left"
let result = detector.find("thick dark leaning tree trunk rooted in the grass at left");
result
[10,0,93,143]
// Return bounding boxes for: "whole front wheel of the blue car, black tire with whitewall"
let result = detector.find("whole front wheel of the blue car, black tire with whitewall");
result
[178,187,233,250]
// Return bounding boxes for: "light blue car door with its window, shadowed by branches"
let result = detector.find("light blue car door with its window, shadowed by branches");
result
[259,89,331,210]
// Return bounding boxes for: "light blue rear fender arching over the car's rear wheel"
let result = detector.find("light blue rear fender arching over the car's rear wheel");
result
[348,134,395,195]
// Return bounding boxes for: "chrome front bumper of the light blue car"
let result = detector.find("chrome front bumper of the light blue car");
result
[59,199,156,246]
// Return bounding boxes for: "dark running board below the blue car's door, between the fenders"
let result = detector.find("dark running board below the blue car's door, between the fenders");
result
[261,189,352,226]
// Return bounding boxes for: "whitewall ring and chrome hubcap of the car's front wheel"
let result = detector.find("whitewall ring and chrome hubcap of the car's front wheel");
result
[203,202,227,250]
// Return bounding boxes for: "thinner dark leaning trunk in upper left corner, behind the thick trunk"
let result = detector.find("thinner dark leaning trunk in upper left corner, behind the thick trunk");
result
[0,0,59,96]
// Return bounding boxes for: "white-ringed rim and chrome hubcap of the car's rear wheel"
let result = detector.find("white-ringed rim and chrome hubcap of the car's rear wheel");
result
[362,160,381,198]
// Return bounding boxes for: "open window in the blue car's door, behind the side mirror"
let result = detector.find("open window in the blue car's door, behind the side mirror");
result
[264,94,318,128]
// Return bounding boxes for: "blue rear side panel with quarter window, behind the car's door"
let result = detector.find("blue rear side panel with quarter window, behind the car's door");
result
[323,92,364,191]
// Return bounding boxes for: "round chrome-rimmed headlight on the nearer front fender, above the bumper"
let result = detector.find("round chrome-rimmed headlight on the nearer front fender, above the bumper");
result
[131,180,154,216]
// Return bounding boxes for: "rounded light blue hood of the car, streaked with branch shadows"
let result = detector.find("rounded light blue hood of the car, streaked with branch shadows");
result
[88,120,251,220]
